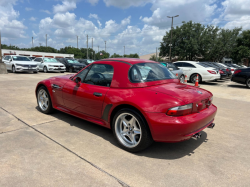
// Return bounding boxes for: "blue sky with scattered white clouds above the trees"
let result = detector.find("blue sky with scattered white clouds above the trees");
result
[0,0,250,56]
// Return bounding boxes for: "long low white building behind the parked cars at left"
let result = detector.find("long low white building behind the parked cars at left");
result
[2,49,74,58]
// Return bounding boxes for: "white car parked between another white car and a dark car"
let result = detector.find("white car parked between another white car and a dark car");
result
[34,57,66,73]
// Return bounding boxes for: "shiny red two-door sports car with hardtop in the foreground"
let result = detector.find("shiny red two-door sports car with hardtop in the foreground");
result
[36,58,217,152]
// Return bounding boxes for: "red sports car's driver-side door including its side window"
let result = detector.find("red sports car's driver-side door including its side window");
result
[63,64,114,118]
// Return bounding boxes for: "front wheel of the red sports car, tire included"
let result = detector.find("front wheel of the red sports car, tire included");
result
[36,86,54,114]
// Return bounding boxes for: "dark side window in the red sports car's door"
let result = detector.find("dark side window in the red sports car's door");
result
[84,64,114,87]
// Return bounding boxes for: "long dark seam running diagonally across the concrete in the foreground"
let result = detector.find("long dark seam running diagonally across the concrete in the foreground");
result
[0,107,129,187]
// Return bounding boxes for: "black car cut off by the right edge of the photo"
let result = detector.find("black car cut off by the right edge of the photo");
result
[231,68,250,88]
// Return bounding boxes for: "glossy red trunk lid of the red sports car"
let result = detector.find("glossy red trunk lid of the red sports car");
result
[146,83,212,104]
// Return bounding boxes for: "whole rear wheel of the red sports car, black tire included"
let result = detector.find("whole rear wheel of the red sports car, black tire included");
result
[112,108,153,152]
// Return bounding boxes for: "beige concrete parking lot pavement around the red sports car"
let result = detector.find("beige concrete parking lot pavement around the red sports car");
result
[0,73,250,186]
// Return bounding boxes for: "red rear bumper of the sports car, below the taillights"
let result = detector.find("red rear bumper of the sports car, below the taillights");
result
[145,105,217,142]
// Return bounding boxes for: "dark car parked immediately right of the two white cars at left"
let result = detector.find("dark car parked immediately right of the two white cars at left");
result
[56,58,86,72]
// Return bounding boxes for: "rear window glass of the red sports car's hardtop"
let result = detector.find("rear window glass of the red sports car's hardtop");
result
[129,63,176,82]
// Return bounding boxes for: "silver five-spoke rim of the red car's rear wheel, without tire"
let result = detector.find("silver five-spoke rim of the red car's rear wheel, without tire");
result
[115,113,142,148]
